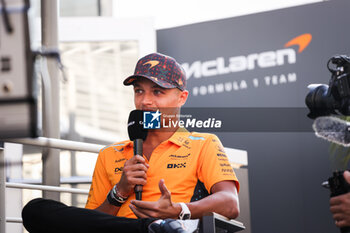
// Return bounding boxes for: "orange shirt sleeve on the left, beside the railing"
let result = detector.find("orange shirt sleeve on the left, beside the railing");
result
[85,149,112,209]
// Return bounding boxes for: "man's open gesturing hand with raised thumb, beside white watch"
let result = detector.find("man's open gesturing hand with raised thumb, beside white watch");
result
[129,179,181,219]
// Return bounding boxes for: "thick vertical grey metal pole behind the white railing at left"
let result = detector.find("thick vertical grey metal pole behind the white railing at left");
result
[41,0,60,201]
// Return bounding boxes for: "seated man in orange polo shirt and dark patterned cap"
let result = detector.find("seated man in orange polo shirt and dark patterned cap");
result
[21,53,239,233]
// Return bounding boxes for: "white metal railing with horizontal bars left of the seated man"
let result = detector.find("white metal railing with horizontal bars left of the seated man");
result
[0,137,104,232]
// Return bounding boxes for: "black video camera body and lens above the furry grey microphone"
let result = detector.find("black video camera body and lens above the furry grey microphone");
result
[305,55,350,119]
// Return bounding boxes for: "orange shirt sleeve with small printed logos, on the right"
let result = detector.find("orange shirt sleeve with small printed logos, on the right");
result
[198,135,239,193]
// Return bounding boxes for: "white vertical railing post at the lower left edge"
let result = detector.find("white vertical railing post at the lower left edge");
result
[0,147,6,233]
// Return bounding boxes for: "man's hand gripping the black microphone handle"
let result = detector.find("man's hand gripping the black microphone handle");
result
[118,155,149,197]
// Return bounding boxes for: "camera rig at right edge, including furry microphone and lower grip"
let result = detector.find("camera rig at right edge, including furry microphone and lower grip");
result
[305,55,350,233]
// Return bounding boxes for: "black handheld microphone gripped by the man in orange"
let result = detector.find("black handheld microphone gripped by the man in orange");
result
[128,110,147,200]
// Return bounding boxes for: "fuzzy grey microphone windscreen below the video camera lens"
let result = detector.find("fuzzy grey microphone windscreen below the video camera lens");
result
[312,116,350,147]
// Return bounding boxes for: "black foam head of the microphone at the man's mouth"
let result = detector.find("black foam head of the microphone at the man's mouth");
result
[128,110,147,141]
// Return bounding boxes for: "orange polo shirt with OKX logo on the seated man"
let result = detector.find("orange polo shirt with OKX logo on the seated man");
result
[86,129,239,218]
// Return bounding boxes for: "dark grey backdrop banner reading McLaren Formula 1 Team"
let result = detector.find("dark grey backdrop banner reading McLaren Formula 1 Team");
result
[157,0,350,233]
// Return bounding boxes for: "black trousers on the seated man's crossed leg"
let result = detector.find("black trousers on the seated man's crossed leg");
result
[22,198,155,233]
